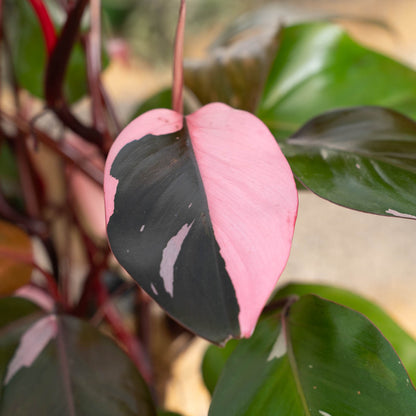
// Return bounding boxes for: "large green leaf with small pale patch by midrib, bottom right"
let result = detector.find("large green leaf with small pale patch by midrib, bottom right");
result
[209,295,416,416]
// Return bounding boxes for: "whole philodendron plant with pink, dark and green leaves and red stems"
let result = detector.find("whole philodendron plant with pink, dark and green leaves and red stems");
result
[0,0,416,416]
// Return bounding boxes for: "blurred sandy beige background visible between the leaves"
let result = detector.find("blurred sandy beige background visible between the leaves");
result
[54,0,416,416]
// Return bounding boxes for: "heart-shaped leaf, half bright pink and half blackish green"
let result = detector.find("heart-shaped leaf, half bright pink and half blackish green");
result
[104,103,297,343]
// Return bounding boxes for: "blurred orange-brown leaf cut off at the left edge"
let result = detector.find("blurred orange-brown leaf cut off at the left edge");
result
[0,220,32,296]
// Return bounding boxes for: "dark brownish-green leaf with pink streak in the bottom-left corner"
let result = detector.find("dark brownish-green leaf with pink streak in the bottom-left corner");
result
[0,298,156,416]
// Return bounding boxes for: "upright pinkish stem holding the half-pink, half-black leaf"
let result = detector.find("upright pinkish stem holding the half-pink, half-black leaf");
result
[172,0,186,114]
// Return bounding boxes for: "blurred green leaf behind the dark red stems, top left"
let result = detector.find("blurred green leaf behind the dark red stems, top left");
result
[5,0,100,103]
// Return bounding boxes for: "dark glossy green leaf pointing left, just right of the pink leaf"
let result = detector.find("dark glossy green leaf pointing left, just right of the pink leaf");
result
[281,107,416,219]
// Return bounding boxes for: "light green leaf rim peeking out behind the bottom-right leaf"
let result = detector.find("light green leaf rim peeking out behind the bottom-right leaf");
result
[270,284,416,384]
